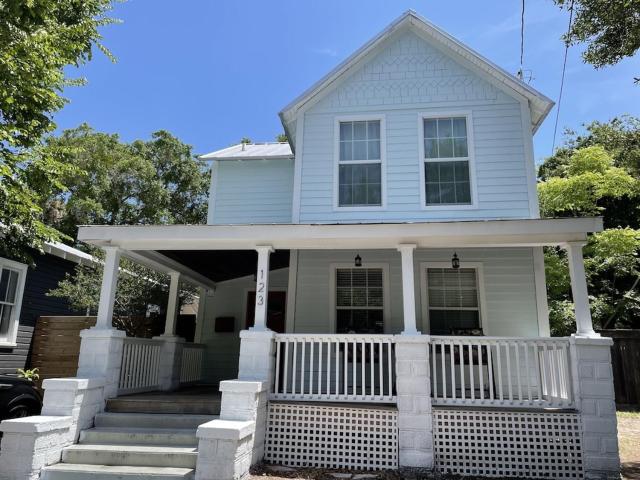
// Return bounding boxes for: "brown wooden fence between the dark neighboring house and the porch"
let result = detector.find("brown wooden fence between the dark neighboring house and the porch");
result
[29,317,96,388]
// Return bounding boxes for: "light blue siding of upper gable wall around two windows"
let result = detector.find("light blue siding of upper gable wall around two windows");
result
[300,32,531,223]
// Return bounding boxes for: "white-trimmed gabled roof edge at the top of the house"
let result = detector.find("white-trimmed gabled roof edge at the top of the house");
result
[279,10,554,149]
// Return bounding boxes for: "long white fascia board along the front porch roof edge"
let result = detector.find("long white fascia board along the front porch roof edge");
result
[78,217,602,249]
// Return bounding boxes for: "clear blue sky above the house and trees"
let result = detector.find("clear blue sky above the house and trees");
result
[55,0,640,161]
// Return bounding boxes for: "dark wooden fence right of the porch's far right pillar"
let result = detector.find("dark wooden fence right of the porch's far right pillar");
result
[600,330,640,406]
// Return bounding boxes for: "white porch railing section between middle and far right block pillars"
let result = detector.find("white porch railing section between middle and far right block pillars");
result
[430,336,574,408]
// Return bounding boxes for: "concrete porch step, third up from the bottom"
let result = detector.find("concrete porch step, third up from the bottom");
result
[79,427,198,447]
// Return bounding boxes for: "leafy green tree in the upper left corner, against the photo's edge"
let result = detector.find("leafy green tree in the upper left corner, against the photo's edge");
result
[0,0,114,258]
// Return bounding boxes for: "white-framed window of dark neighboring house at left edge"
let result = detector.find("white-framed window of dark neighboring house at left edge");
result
[0,258,27,345]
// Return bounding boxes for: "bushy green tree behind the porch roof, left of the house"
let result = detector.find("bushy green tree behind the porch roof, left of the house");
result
[44,124,209,237]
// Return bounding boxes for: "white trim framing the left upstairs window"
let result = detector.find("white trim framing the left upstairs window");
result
[333,113,387,212]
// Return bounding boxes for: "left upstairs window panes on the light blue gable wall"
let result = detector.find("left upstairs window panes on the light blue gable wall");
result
[338,120,383,207]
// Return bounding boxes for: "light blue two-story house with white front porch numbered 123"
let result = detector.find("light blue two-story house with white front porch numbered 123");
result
[0,11,618,479]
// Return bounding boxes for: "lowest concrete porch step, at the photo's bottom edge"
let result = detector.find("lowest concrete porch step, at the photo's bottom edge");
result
[40,463,195,480]
